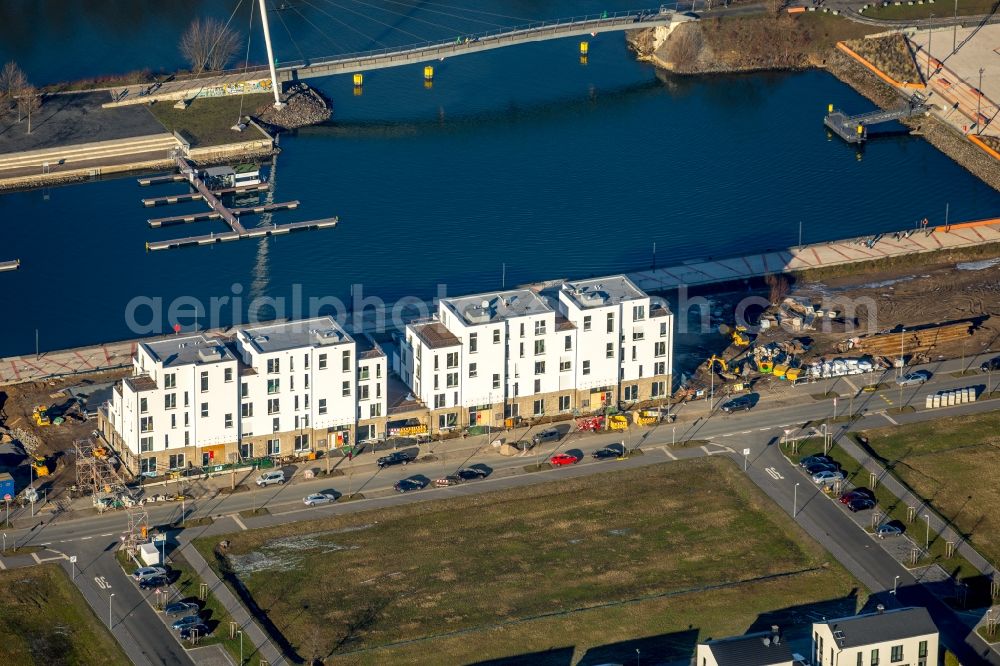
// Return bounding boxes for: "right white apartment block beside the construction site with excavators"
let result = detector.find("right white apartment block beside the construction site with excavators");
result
[399,275,673,430]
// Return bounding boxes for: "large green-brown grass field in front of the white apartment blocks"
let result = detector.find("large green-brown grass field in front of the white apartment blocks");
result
[197,459,857,664]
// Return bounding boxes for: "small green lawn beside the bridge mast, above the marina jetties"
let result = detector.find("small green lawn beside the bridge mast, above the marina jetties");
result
[149,94,271,148]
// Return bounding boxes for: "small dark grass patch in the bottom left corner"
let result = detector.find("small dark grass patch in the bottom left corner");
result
[0,564,131,666]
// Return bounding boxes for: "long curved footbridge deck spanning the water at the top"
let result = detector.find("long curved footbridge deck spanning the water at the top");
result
[279,3,677,70]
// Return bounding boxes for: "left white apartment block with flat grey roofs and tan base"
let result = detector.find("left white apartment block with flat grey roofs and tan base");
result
[100,317,387,476]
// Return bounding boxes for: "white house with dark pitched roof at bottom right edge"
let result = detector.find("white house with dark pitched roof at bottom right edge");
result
[812,608,941,666]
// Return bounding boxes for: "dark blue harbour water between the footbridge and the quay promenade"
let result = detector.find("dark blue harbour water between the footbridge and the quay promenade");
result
[0,3,1000,355]
